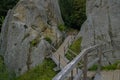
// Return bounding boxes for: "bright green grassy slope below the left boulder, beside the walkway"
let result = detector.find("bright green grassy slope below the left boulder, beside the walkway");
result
[16,59,57,80]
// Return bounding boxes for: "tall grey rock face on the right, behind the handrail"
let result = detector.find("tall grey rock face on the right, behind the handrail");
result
[79,0,120,65]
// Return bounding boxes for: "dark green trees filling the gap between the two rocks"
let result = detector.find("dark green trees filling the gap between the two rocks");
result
[59,0,86,29]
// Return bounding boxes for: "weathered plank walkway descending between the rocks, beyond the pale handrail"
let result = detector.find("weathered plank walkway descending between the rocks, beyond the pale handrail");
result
[51,35,74,69]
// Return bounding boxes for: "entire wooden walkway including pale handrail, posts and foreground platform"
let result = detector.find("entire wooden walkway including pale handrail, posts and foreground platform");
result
[51,36,120,80]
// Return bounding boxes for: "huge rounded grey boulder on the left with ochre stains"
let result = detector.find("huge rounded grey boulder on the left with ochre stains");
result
[0,0,63,75]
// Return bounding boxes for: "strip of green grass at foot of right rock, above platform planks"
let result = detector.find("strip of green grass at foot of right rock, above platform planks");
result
[89,61,120,71]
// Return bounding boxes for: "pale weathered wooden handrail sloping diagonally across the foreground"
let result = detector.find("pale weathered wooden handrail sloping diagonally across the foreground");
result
[52,45,100,80]
